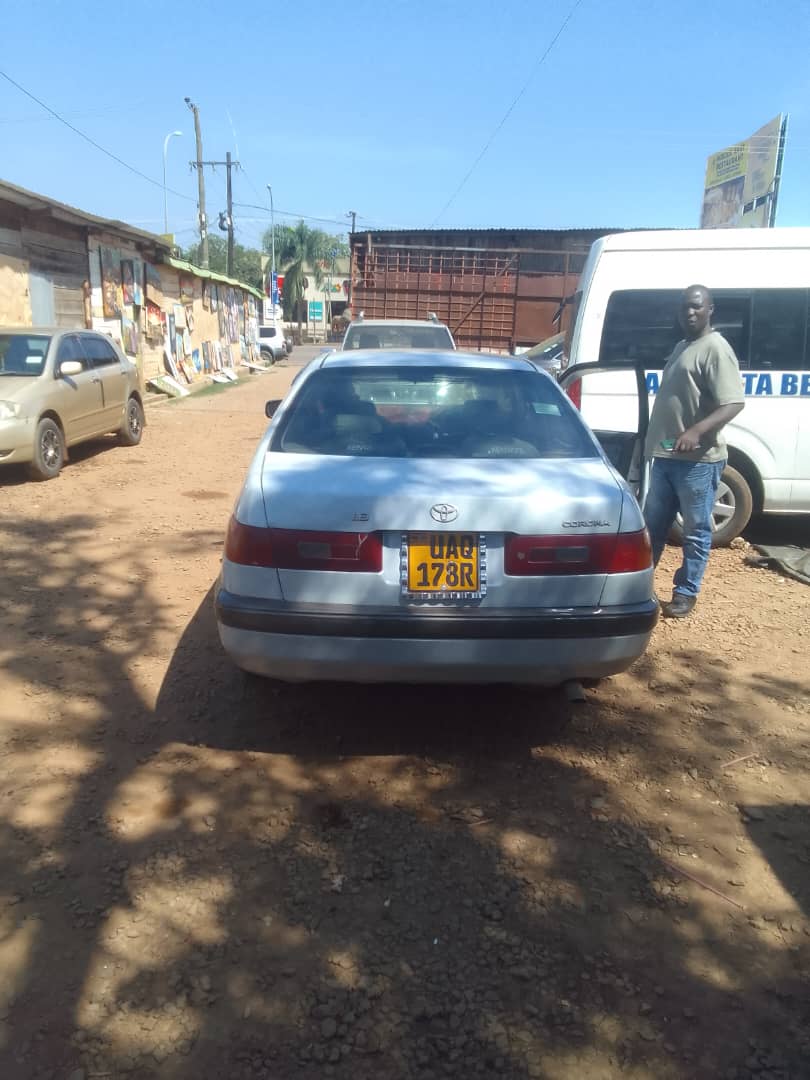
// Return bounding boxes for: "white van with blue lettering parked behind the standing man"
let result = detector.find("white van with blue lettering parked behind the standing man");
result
[561,228,810,546]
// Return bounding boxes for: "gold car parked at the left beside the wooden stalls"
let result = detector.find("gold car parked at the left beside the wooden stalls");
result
[0,328,145,480]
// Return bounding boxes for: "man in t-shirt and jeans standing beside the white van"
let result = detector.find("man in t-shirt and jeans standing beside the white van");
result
[645,285,745,619]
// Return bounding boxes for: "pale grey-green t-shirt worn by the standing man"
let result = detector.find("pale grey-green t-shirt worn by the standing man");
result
[646,330,745,461]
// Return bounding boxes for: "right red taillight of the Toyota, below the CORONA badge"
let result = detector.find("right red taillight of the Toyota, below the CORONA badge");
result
[503,529,652,578]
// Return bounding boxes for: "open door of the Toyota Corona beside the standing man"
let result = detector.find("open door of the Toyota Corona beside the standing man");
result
[559,362,650,505]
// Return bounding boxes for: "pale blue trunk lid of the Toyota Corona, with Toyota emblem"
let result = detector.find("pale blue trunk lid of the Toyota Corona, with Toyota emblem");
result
[262,453,623,608]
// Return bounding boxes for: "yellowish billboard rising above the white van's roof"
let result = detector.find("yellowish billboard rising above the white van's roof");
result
[700,116,787,229]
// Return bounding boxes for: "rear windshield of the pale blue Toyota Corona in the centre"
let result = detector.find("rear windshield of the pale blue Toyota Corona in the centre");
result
[270,367,597,458]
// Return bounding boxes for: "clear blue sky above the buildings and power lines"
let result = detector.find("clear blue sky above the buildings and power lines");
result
[0,0,810,250]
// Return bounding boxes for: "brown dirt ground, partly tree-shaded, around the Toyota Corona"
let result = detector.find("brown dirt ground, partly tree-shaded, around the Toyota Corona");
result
[0,351,810,1080]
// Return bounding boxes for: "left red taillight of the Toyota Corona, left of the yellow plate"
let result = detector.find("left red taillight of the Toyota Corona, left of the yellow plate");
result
[225,517,382,573]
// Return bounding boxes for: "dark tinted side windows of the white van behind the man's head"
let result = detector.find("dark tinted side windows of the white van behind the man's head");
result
[599,288,810,370]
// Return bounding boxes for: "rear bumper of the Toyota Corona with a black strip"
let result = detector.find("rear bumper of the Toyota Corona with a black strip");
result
[216,590,658,686]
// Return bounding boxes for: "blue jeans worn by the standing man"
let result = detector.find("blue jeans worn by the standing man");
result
[644,458,726,596]
